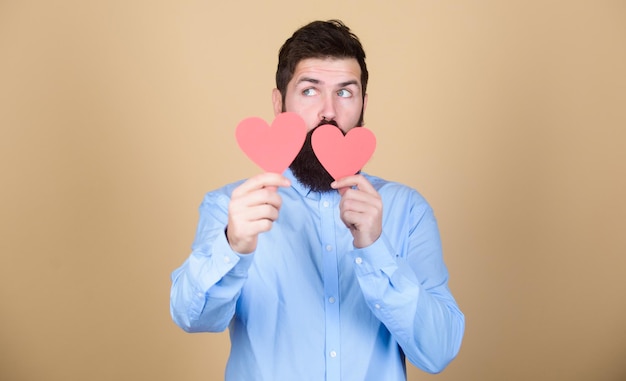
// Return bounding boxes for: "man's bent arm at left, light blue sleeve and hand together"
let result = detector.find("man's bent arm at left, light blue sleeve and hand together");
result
[170,173,289,332]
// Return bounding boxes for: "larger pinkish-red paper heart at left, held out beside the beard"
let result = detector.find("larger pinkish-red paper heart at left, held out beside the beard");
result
[235,112,307,173]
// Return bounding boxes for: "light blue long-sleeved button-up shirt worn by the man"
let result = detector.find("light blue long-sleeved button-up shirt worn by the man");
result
[171,170,465,381]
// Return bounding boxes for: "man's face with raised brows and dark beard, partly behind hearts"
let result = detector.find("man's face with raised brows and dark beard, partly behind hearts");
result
[272,58,367,192]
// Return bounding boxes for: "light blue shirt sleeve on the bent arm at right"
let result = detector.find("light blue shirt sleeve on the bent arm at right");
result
[352,186,465,373]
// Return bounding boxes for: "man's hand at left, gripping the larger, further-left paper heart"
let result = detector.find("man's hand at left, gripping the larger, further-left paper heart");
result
[226,172,290,254]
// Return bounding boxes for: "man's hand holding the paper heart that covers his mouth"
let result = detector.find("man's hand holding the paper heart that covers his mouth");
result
[331,175,383,248]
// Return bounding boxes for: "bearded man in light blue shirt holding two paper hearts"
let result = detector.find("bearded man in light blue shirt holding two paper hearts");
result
[171,20,464,381]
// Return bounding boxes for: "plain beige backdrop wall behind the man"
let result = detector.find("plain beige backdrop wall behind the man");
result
[0,0,626,381]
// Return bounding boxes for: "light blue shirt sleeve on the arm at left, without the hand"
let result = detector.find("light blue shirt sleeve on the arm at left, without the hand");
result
[170,193,254,332]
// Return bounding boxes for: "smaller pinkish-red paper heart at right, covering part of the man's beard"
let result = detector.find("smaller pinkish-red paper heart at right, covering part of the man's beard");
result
[311,124,376,180]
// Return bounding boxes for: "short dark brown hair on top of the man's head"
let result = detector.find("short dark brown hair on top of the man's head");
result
[276,20,368,103]
